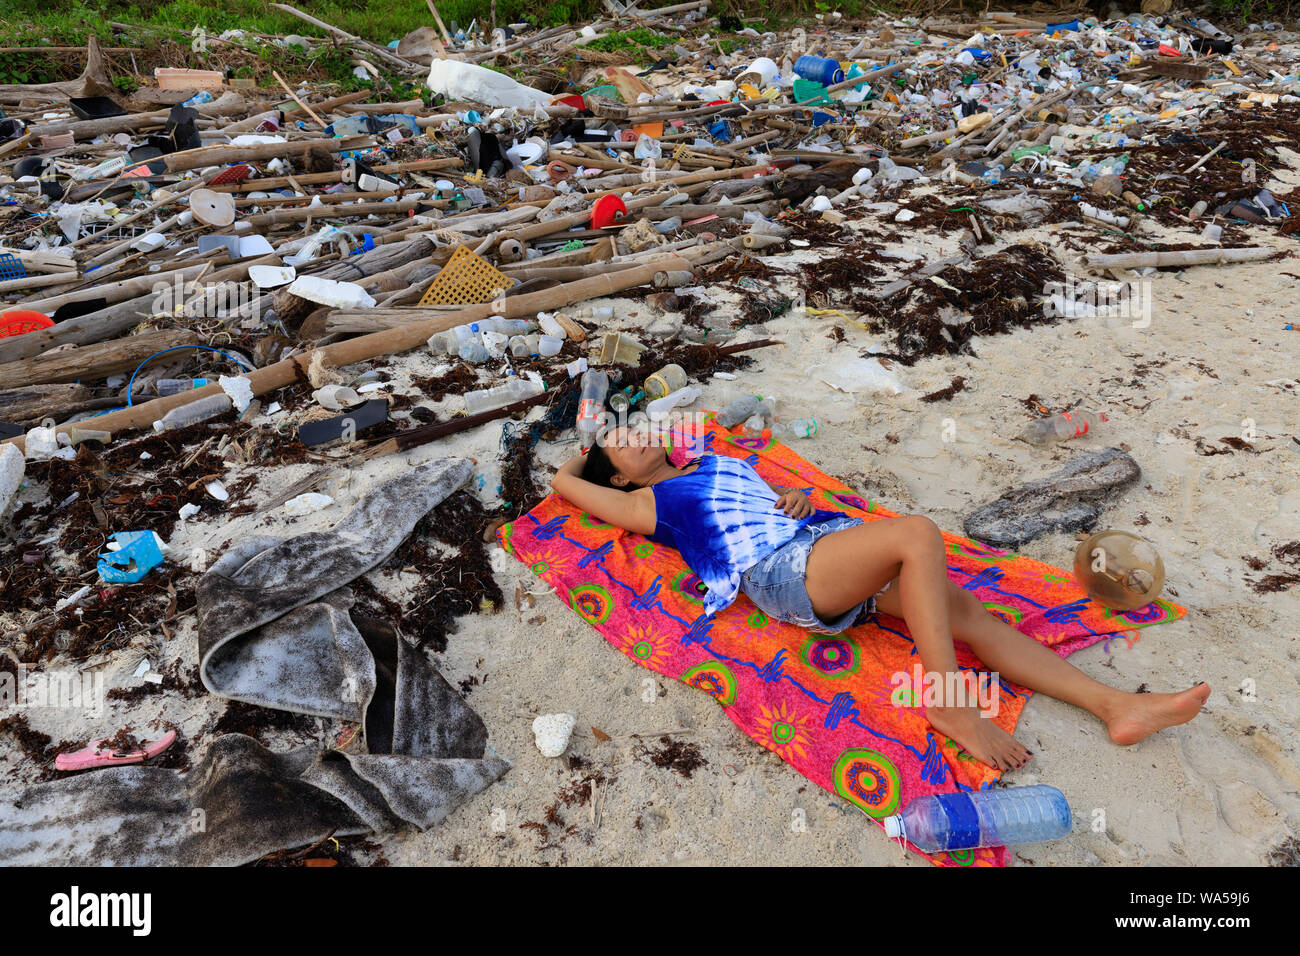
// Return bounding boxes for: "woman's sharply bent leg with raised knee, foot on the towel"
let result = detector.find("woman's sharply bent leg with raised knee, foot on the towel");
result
[805,515,1030,770]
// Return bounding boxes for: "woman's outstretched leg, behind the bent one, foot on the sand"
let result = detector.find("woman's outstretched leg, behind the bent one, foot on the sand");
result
[876,581,1210,744]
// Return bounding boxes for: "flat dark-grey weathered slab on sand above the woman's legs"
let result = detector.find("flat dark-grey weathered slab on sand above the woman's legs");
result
[962,449,1141,548]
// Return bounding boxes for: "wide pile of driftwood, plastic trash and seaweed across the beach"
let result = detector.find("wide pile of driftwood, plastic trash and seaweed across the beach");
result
[0,0,1300,863]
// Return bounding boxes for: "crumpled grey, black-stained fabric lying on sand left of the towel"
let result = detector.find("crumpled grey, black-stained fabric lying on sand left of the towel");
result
[0,459,510,866]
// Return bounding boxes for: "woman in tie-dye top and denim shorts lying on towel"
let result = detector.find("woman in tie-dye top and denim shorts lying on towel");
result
[551,428,1210,770]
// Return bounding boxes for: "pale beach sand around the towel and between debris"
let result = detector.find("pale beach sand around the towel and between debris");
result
[0,174,1300,865]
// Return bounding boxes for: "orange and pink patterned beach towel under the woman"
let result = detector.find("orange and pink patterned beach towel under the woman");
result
[498,414,1184,866]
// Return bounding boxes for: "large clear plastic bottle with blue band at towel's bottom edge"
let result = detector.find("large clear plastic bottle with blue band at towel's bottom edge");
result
[884,783,1074,853]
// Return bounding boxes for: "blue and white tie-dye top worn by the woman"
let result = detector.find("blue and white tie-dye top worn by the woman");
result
[650,455,836,614]
